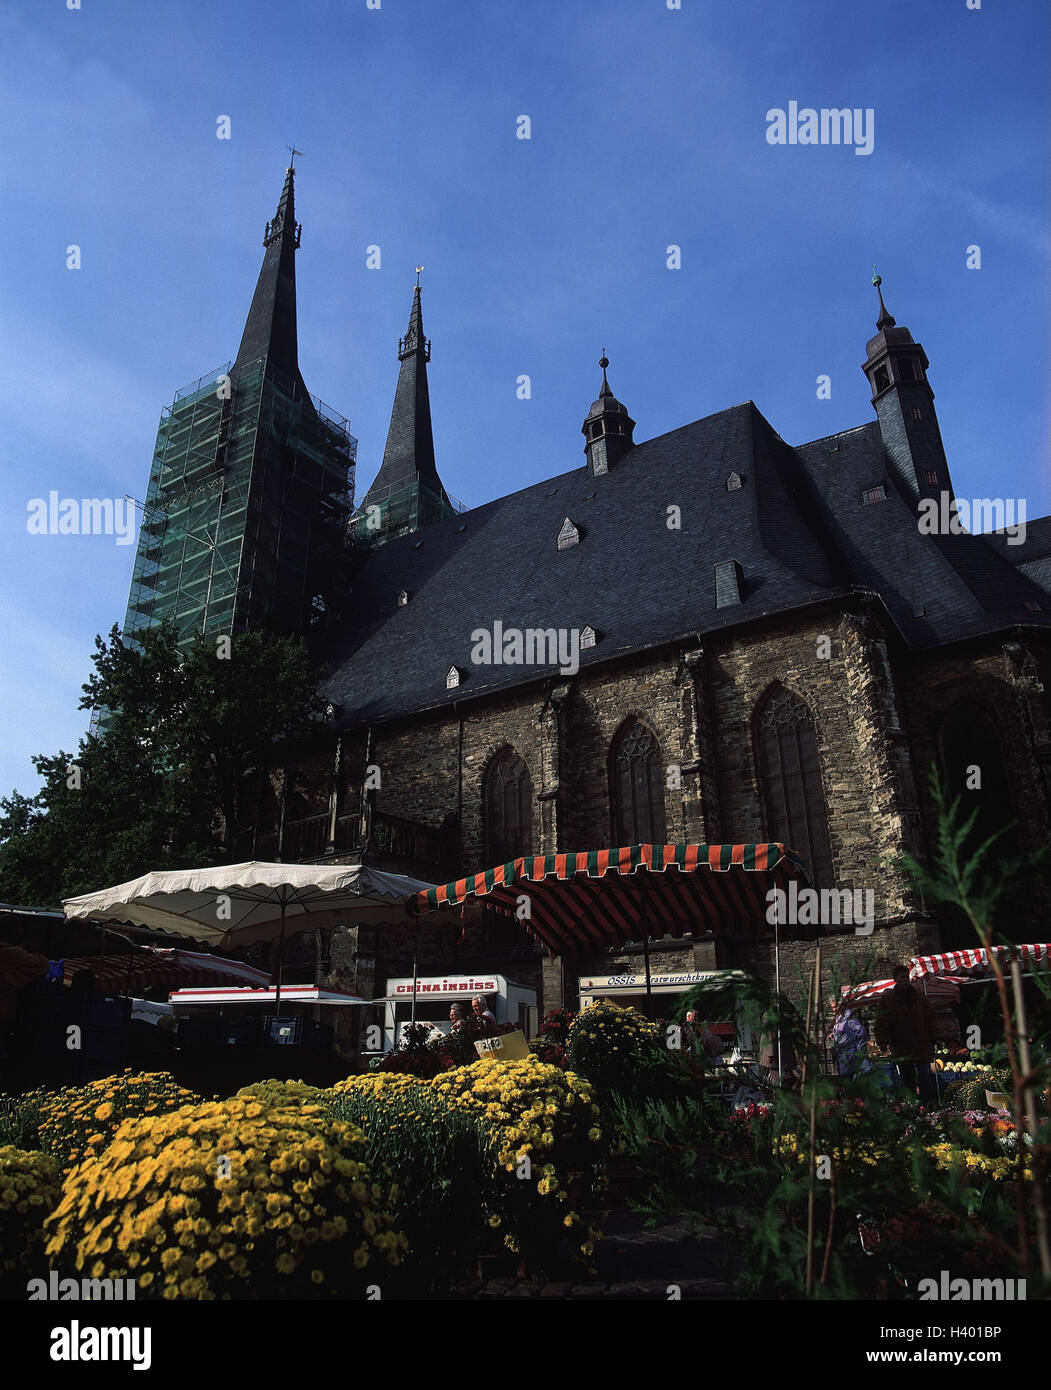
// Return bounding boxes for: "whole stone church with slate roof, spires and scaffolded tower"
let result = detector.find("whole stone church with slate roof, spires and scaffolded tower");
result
[116,170,1051,1028]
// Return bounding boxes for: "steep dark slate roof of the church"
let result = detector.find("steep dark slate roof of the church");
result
[323,402,1051,723]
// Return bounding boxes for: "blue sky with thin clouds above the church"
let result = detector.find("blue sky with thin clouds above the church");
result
[0,0,1051,794]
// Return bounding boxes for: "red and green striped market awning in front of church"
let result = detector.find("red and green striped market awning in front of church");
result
[409,842,816,955]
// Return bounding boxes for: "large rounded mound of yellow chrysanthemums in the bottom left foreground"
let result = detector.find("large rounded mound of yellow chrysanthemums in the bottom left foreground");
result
[46,1098,406,1300]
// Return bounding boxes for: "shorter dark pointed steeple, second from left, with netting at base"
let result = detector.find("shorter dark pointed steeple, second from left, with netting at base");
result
[359,282,453,539]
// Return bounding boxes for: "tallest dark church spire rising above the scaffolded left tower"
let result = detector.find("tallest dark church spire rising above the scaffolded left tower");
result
[235,161,302,378]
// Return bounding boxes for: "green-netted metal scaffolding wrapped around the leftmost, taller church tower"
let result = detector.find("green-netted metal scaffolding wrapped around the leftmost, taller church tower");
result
[124,357,357,644]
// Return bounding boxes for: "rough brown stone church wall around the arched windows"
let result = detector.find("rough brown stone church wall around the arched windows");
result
[266,605,1051,1009]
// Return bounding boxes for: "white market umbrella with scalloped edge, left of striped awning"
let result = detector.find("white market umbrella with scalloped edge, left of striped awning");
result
[63,860,434,1002]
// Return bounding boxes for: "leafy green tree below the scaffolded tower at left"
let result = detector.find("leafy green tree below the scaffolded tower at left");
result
[0,626,323,906]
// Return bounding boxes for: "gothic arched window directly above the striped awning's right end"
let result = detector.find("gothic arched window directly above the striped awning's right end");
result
[756,687,836,888]
